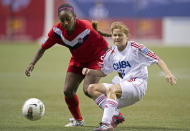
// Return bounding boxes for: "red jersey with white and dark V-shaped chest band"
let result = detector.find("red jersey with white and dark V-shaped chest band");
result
[42,19,108,63]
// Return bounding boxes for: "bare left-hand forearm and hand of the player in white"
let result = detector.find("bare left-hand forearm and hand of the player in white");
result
[82,68,106,77]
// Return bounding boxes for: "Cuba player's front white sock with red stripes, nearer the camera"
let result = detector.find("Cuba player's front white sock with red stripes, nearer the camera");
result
[102,99,118,124]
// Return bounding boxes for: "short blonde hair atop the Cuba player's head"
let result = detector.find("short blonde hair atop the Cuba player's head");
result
[111,21,129,36]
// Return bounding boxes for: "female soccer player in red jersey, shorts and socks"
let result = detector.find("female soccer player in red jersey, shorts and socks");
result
[25,3,108,127]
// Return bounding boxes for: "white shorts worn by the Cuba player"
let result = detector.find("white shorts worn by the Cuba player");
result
[103,78,147,108]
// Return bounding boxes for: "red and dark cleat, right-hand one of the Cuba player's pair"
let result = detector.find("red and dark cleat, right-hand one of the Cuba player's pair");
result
[111,113,125,128]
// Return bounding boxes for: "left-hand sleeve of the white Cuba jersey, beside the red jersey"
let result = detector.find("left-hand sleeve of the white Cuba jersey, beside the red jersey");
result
[101,49,114,75]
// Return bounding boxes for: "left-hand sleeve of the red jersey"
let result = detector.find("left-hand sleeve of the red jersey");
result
[41,28,57,49]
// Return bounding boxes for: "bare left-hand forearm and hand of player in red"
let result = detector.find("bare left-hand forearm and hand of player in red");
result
[25,48,45,77]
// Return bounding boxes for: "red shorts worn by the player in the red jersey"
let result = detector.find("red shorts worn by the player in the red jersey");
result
[67,52,105,75]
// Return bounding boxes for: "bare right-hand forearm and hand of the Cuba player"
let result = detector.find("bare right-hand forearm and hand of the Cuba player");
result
[158,59,176,85]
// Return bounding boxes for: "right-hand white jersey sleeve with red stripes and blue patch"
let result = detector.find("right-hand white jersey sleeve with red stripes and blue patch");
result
[138,44,160,66]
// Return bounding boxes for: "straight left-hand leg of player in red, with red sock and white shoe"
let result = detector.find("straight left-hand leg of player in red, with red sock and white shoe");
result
[64,72,84,127]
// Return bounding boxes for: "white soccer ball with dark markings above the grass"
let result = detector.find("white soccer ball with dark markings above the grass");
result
[22,98,45,121]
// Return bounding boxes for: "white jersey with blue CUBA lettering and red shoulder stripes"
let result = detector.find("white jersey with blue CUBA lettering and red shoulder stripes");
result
[101,41,159,80]
